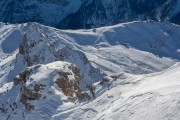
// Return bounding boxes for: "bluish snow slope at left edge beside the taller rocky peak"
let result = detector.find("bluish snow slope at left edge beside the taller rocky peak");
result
[0,23,26,86]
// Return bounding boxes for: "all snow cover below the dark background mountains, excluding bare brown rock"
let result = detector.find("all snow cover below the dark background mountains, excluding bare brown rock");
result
[0,22,180,120]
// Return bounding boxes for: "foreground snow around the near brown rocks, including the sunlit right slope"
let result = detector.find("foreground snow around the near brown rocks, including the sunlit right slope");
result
[0,62,180,120]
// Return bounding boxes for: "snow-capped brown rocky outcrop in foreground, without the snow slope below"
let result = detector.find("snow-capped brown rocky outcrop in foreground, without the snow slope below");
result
[13,61,90,111]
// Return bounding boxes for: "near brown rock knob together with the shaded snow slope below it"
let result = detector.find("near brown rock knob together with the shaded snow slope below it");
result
[0,61,81,120]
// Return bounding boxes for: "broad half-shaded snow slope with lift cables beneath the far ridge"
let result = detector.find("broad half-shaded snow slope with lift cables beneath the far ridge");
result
[30,22,180,73]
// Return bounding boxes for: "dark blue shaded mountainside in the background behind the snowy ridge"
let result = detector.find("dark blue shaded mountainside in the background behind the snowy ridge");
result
[0,0,180,29]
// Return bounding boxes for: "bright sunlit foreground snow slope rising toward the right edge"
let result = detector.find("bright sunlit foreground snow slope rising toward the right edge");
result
[53,63,180,120]
